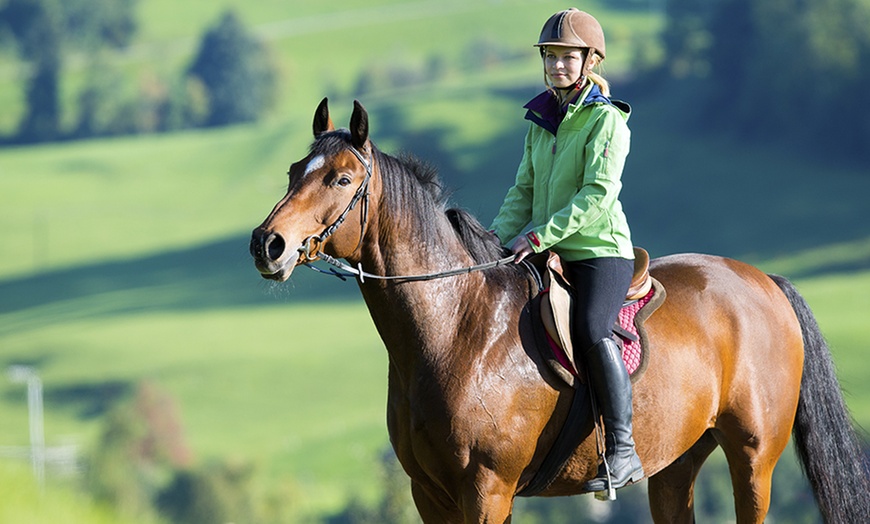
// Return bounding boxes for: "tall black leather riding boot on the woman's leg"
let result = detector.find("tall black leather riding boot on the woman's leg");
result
[584,338,644,492]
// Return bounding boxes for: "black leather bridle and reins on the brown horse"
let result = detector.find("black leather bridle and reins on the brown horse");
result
[297,146,525,283]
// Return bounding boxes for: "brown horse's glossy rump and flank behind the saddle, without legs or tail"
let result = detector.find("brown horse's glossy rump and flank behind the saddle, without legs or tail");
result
[635,254,803,473]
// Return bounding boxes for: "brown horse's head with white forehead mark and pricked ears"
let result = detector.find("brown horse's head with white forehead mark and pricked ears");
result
[251,98,374,281]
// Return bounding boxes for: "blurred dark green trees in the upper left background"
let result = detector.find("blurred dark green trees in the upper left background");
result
[0,0,276,143]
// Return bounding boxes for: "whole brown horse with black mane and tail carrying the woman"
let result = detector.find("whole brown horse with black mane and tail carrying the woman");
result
[251,99,870,524]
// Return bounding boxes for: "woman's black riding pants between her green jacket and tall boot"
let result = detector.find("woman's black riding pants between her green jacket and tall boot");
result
[567,257,634,356]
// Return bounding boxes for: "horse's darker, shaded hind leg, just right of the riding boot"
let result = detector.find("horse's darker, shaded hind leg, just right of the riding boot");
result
[649,431,718,524]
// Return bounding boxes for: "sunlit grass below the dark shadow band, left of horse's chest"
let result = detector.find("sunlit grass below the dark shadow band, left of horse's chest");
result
[0,302,387,507]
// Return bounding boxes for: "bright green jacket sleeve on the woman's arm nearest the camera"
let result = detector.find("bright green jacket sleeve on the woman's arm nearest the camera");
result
[532,108,630,252]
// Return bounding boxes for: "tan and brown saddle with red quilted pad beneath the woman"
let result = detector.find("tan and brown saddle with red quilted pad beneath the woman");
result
[532,247,665,387]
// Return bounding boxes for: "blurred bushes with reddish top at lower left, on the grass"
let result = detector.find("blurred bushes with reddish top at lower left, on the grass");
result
[83,382,295,524]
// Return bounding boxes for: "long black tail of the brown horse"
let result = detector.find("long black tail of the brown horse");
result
[771,275,870,523]
